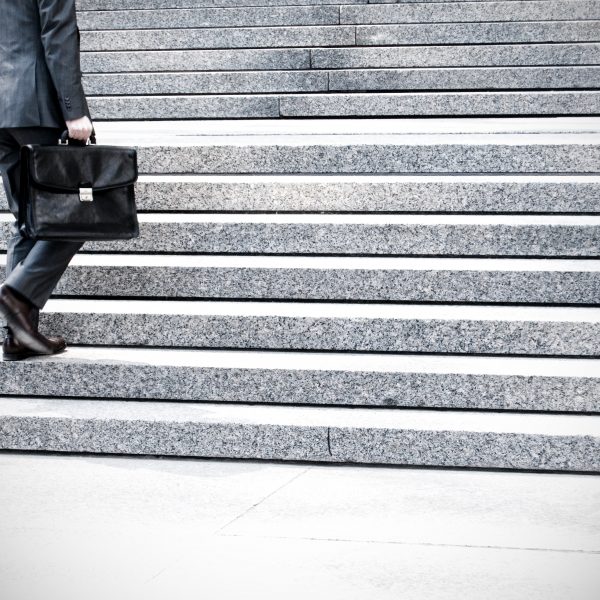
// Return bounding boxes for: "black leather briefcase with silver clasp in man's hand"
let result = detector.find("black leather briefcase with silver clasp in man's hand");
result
[19,134,139,242]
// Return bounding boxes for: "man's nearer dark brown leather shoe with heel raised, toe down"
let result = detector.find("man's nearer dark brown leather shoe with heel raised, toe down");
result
[0,285,58,354]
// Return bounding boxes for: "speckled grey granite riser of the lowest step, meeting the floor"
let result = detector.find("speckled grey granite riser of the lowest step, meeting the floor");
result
[0,416,600,472]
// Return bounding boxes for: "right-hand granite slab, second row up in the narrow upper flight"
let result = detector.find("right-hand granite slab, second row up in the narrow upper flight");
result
[329,66,600,91]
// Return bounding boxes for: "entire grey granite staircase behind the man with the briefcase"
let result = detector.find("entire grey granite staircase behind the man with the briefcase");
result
[0,0,600,472]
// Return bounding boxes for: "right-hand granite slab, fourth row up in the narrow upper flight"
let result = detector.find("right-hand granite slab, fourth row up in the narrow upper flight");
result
[356,20,600,46]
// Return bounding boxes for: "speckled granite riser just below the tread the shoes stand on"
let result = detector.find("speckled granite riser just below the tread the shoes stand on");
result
[0,360,600,413]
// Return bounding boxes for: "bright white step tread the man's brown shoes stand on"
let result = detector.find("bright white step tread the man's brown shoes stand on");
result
[5,344,600,378]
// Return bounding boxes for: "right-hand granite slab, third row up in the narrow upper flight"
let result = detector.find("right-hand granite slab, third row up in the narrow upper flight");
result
[311,43,600,69]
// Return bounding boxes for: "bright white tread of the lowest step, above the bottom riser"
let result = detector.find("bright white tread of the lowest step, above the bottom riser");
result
[0,397,600,436]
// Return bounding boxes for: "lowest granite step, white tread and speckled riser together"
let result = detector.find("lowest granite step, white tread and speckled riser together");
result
[0,398,600,472]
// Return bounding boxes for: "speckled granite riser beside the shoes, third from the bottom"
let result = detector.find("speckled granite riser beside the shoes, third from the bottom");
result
[40,313,600,356]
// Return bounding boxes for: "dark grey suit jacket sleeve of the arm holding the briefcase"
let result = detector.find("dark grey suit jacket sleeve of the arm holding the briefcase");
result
[37,0,88,121]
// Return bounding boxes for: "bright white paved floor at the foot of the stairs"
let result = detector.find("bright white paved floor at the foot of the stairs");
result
[0,454,600,600]
